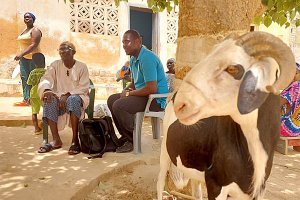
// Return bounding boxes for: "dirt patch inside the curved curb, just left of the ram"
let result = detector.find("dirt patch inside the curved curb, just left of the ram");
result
[84,160,159,200]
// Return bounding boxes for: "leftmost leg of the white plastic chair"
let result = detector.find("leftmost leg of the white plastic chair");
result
[133,112,144,154]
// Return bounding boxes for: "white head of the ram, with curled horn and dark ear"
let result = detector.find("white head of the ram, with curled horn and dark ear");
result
[174,32,295,125]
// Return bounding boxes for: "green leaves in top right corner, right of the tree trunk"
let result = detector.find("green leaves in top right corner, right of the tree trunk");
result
[253,0,300,28]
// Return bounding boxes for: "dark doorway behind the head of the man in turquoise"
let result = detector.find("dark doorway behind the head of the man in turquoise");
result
[130,7,153,50]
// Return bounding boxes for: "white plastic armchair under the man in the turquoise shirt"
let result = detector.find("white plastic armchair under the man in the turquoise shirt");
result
[133,93,169,154]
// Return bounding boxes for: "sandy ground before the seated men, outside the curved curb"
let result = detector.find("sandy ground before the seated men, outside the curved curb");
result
[0,123,160,200]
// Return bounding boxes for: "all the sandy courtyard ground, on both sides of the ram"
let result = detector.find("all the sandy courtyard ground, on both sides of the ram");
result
[0,97,300,200]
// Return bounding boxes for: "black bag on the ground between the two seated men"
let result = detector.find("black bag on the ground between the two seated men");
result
[79,116,119,158]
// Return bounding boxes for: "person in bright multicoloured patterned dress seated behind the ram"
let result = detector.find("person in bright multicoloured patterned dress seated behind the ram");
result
[280,63,300,137]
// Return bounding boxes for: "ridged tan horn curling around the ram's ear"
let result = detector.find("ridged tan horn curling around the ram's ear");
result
[236,32,296,94]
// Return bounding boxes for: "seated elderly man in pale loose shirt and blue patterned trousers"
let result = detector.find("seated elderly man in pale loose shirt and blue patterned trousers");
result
[38,42,89,155]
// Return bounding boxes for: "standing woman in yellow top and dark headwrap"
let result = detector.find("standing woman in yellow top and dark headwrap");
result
[15,12,42,106]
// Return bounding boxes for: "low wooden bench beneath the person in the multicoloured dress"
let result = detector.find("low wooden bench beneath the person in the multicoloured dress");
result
[276,136,300,155]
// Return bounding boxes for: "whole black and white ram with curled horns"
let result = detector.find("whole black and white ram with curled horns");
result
[157,32,295,200]
